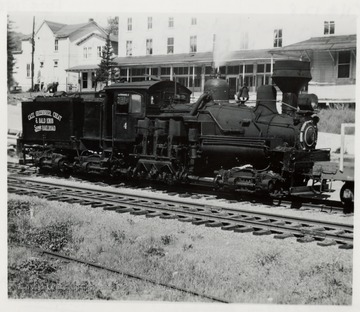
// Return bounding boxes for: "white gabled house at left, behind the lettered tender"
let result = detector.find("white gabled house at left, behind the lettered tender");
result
[14,19,117,91]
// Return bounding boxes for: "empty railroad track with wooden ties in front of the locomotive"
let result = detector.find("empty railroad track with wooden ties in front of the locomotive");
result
[8,176,353,249]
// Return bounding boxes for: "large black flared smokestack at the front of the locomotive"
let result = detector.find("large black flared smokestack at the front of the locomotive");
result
[272,60,311,116]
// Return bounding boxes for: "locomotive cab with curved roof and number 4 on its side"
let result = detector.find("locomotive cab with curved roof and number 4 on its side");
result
[102,81,191,148]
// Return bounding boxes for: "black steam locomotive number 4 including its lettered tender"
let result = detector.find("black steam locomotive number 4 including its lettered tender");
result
[21,60,330,195]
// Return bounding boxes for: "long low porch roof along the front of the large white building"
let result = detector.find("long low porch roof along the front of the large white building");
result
[114,49,278,66]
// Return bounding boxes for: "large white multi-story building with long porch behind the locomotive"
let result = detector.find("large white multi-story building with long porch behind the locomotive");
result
[116,13,356,101]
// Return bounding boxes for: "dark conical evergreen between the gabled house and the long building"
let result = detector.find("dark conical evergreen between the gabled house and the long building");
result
[95,33,117,88]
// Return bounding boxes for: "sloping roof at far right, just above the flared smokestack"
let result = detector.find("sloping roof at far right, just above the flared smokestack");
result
[270,35,356,54]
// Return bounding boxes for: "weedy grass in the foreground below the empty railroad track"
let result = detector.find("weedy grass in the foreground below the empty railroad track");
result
[8,194,352,305]
